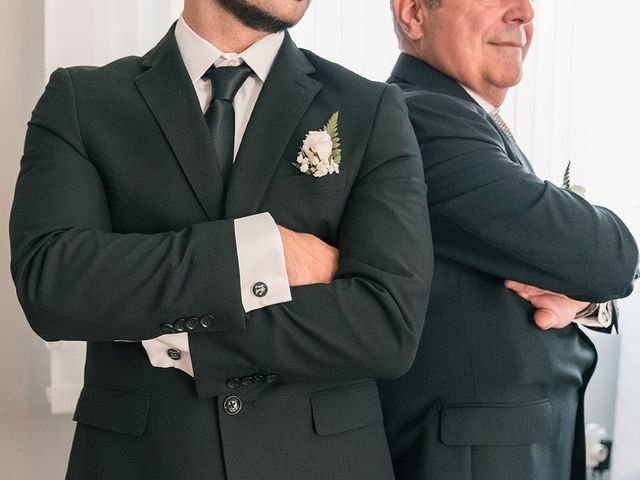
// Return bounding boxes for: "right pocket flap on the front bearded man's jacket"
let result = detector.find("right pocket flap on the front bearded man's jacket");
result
[311,383,382,436]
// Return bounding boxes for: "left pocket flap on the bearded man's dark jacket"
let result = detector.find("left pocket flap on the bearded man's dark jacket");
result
[73,385,150,437]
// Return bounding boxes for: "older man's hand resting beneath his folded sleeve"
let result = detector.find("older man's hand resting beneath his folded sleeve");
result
[504,280,589,330]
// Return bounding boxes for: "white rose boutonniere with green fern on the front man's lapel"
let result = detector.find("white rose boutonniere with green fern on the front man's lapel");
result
[293,112,341,177]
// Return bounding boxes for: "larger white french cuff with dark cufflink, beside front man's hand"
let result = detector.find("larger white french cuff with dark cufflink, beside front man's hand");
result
[234,213,291,312]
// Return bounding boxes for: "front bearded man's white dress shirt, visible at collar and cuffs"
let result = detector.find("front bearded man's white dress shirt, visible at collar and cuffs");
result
[142,16,291,376]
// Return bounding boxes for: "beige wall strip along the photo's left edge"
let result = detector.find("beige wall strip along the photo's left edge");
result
[0,0,73,480]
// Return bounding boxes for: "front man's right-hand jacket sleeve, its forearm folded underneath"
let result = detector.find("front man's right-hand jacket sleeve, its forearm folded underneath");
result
[190,87,433,395]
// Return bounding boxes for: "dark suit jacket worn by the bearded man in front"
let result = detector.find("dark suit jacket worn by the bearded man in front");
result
[11,31,432,480]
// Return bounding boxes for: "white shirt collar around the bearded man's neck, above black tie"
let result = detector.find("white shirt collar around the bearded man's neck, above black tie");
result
[175,15,284,83]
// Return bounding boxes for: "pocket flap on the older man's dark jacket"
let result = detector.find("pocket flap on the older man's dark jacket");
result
[440,400,551,445]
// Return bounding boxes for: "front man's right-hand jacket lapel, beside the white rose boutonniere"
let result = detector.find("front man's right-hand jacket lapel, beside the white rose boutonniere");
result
[225,34,322,218]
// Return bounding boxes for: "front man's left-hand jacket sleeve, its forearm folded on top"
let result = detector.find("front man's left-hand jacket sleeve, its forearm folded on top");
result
[10,69,245,341]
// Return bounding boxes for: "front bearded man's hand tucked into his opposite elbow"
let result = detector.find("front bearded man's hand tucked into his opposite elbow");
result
[278,225,340,287]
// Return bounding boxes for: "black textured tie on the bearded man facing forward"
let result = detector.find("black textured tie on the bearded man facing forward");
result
[202,64,251,185]
